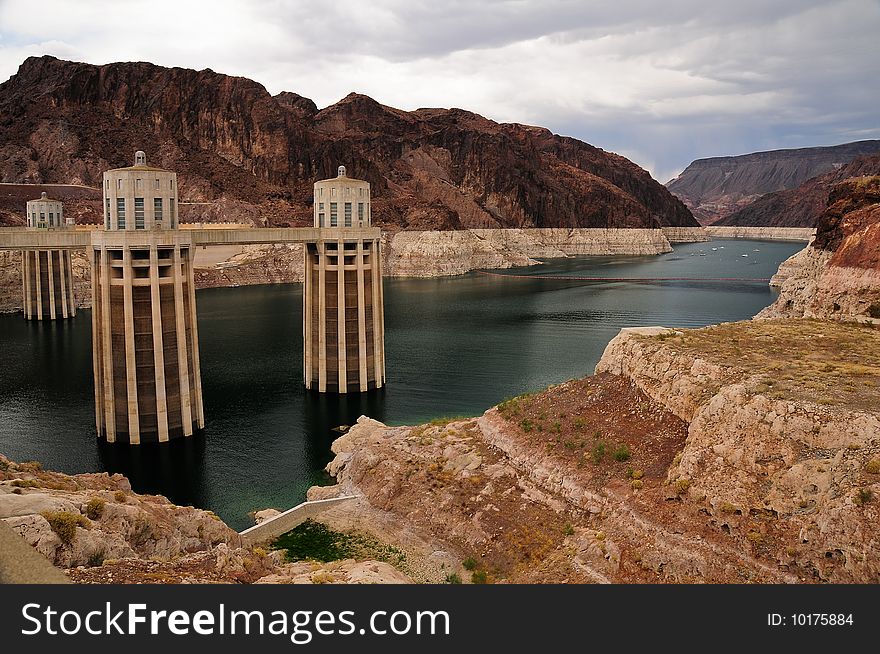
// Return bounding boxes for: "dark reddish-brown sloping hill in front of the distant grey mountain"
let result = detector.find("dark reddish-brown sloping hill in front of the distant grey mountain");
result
[715,155,880,227]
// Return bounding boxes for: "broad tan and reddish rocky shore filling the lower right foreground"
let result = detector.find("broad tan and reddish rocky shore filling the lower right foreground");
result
[310,321,880,583]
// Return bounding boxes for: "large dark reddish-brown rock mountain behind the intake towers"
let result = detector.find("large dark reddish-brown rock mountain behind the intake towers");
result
[0,56,697,229]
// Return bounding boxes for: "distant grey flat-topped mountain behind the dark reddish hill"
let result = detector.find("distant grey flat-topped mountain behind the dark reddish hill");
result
[666,141,880,227]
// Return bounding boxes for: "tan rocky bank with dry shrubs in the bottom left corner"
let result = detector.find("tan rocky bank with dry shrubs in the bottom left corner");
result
[0,455,409,583]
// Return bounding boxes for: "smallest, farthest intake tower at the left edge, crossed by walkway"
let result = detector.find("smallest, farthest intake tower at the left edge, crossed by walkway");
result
[21,193,76,320]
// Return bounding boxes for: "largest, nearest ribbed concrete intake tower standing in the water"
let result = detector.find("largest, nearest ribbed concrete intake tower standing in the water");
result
[92,151,205,444]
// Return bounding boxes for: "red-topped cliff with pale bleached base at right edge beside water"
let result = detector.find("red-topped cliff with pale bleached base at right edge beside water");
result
[758,176,880,321]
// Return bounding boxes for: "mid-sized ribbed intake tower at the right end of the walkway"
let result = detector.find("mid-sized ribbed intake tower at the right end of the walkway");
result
[303,166,385,393]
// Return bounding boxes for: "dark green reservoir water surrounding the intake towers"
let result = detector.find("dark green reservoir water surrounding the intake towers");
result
[0,240,803,528]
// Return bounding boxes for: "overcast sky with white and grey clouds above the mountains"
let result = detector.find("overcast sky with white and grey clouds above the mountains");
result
[0,0,880,182]
